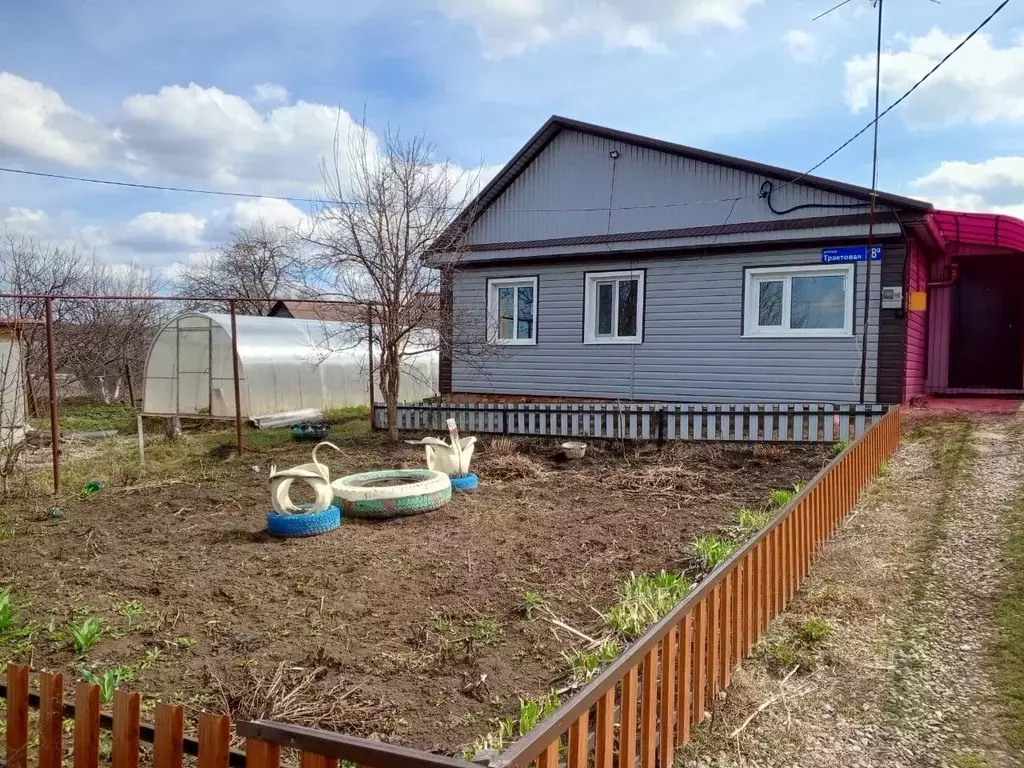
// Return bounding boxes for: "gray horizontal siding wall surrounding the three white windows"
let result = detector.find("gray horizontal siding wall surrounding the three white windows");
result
[452,248,881,402]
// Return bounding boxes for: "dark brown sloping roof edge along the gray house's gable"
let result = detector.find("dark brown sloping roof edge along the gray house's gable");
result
[431,115,932,250]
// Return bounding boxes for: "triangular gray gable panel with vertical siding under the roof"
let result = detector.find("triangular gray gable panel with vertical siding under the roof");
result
[469,130,865,244]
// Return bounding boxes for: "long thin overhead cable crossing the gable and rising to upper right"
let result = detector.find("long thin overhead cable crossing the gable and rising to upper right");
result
[0,0,1010,218]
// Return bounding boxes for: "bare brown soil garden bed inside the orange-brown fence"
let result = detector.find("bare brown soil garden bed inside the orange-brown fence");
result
[0,433,827,754]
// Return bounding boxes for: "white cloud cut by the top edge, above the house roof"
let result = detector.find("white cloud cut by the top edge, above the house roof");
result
[438,0,761,57]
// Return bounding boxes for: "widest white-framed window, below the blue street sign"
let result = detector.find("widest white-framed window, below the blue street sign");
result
[743,264,854,336]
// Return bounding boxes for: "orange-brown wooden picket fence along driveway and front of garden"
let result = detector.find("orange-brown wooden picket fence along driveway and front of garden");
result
[6,409,900,768]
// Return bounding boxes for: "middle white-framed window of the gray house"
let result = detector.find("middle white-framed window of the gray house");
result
[583,269,644,344]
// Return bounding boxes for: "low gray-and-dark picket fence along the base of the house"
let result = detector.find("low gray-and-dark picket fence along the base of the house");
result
[374,402,889,442]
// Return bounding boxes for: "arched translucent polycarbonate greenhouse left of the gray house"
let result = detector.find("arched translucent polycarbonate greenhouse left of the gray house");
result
[143,313,437,420]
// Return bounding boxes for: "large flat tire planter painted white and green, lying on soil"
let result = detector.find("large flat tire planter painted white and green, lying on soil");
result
[331,469,452,519]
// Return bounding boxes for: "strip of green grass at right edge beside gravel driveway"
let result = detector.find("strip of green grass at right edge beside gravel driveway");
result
[991,496,1024,749]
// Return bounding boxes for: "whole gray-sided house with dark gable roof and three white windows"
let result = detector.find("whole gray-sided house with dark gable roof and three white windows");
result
[427,117,931,403]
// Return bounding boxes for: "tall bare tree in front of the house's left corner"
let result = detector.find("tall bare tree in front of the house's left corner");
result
[307,122,478,438]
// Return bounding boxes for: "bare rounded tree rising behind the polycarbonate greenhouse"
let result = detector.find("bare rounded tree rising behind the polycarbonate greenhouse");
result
[176,220,309,314]
